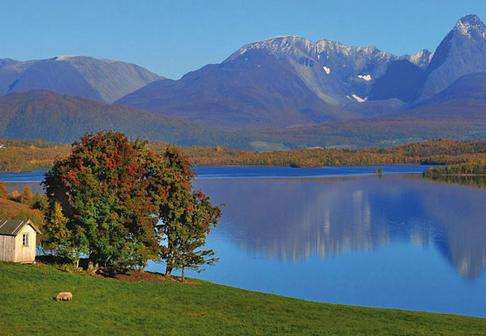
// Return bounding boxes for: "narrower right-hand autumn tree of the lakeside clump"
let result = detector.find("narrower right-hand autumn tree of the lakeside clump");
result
[143,146,220,275]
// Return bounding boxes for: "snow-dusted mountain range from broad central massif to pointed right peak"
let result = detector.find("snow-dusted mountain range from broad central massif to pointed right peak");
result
[117,15,486,128]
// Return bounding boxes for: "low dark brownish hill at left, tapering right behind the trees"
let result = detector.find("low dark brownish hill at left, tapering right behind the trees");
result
[0,91,237,145]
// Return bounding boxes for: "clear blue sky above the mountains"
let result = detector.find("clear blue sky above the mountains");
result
[0,0,486,78]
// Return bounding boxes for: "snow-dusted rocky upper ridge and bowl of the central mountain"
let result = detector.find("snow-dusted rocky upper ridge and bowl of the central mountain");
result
[225,36,396,105]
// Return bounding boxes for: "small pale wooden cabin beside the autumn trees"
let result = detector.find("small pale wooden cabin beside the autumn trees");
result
[0,219,40,263]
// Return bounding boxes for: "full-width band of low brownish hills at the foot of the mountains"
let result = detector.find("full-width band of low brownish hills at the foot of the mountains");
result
[0,91,486,151]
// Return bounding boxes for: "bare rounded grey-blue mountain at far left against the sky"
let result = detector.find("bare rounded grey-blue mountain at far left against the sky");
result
[0,56,160,103]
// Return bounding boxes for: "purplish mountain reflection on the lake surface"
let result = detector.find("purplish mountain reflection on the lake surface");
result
[198,176,486,278]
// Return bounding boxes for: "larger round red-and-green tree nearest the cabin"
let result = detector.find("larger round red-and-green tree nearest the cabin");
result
[44,132,158,272]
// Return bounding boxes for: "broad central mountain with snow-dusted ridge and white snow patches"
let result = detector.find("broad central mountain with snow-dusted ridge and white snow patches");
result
[117,36,410,128]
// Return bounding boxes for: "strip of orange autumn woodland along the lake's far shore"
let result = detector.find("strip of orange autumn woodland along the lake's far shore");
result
[0,140,486,172]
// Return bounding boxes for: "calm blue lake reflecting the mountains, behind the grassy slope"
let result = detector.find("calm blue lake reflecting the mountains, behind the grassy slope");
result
[0,166,486,317]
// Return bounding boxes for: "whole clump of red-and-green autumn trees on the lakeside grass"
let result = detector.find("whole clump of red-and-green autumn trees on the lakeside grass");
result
[44,132,220,274]
